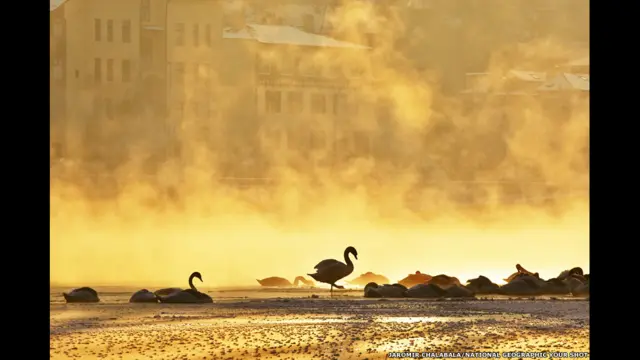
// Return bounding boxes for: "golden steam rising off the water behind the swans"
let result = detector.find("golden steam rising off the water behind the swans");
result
[50,2,589,286]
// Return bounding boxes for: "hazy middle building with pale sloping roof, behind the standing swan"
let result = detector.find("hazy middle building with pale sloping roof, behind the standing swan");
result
[166,0,378,174]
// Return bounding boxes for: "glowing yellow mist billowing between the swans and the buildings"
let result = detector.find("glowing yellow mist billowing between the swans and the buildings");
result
[50,0,589,287]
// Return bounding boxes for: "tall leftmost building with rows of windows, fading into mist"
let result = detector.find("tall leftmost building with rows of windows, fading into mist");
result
[50,0,167,156]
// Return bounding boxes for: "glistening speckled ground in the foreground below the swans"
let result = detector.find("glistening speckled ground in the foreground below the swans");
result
[50,297,590,360]
